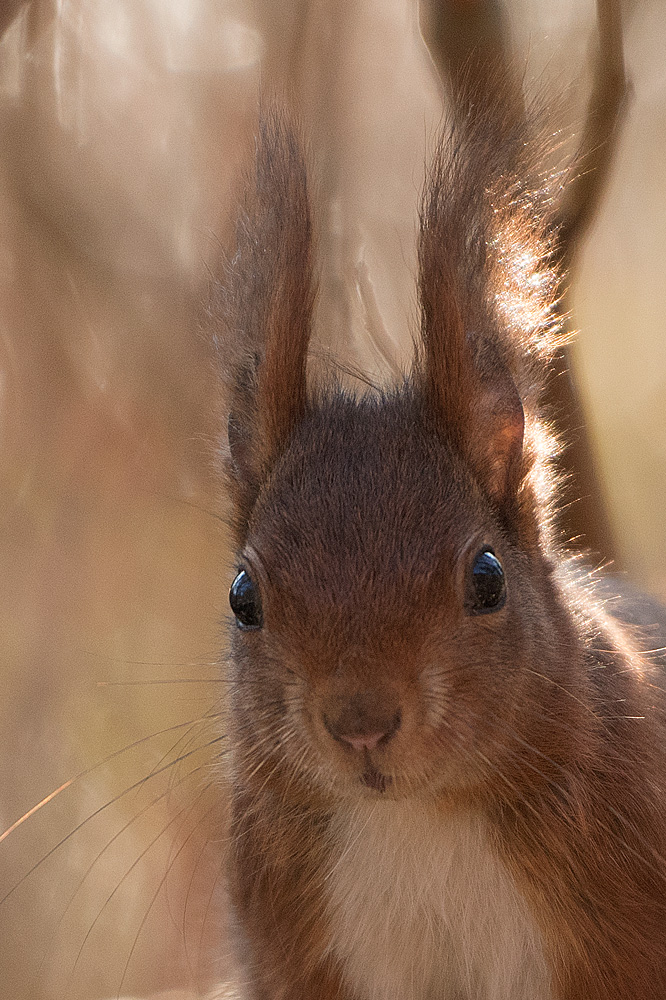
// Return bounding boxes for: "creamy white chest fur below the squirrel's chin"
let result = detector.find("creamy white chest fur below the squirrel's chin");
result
[326,802,552,1000]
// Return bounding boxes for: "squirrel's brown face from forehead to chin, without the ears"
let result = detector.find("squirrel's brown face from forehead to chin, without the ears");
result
[227,387,567,797]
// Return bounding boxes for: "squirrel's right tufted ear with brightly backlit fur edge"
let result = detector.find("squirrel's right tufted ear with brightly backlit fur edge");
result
[416,98,557,506]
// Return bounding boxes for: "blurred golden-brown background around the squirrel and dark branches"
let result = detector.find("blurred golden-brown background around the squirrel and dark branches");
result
[0,0,666,1000]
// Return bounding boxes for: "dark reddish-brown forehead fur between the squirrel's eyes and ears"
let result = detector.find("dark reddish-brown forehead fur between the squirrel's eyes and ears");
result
[249,389,492,603]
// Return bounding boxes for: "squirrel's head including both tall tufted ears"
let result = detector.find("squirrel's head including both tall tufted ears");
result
[215,103,577,796]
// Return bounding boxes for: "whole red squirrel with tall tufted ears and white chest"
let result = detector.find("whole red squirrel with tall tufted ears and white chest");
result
[214,108,666,1000]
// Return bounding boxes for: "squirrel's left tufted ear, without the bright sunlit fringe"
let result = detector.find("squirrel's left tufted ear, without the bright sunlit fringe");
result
[215,109,315,521]
